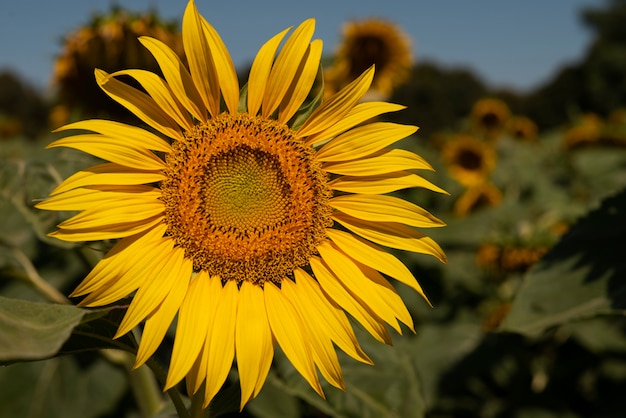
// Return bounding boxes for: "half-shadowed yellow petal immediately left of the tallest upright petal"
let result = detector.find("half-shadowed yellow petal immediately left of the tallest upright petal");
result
[139,36,207,122]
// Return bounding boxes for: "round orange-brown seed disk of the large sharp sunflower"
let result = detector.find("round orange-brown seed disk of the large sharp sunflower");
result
[161,114,331,284]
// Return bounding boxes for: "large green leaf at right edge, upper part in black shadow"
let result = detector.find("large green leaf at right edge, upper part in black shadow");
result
[501,190,626,336]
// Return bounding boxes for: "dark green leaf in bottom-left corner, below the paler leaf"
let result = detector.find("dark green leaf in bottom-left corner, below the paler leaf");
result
[0,356,127,418]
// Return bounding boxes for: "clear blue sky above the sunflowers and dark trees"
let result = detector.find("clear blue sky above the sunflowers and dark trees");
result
[0,0,606,90]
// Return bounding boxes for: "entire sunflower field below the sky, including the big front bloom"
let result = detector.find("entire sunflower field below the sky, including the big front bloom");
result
[0,1,626,418]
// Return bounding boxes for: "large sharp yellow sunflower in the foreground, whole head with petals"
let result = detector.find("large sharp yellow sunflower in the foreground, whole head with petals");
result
[38,1,446,408]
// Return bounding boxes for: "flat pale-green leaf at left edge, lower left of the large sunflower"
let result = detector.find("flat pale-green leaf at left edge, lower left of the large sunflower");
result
[0,296,87,362]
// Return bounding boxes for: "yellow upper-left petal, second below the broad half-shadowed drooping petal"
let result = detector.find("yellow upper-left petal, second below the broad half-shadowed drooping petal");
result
[48,134,165,170]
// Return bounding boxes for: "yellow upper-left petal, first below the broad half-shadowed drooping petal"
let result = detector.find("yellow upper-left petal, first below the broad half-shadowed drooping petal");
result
[53,119,172,153]
